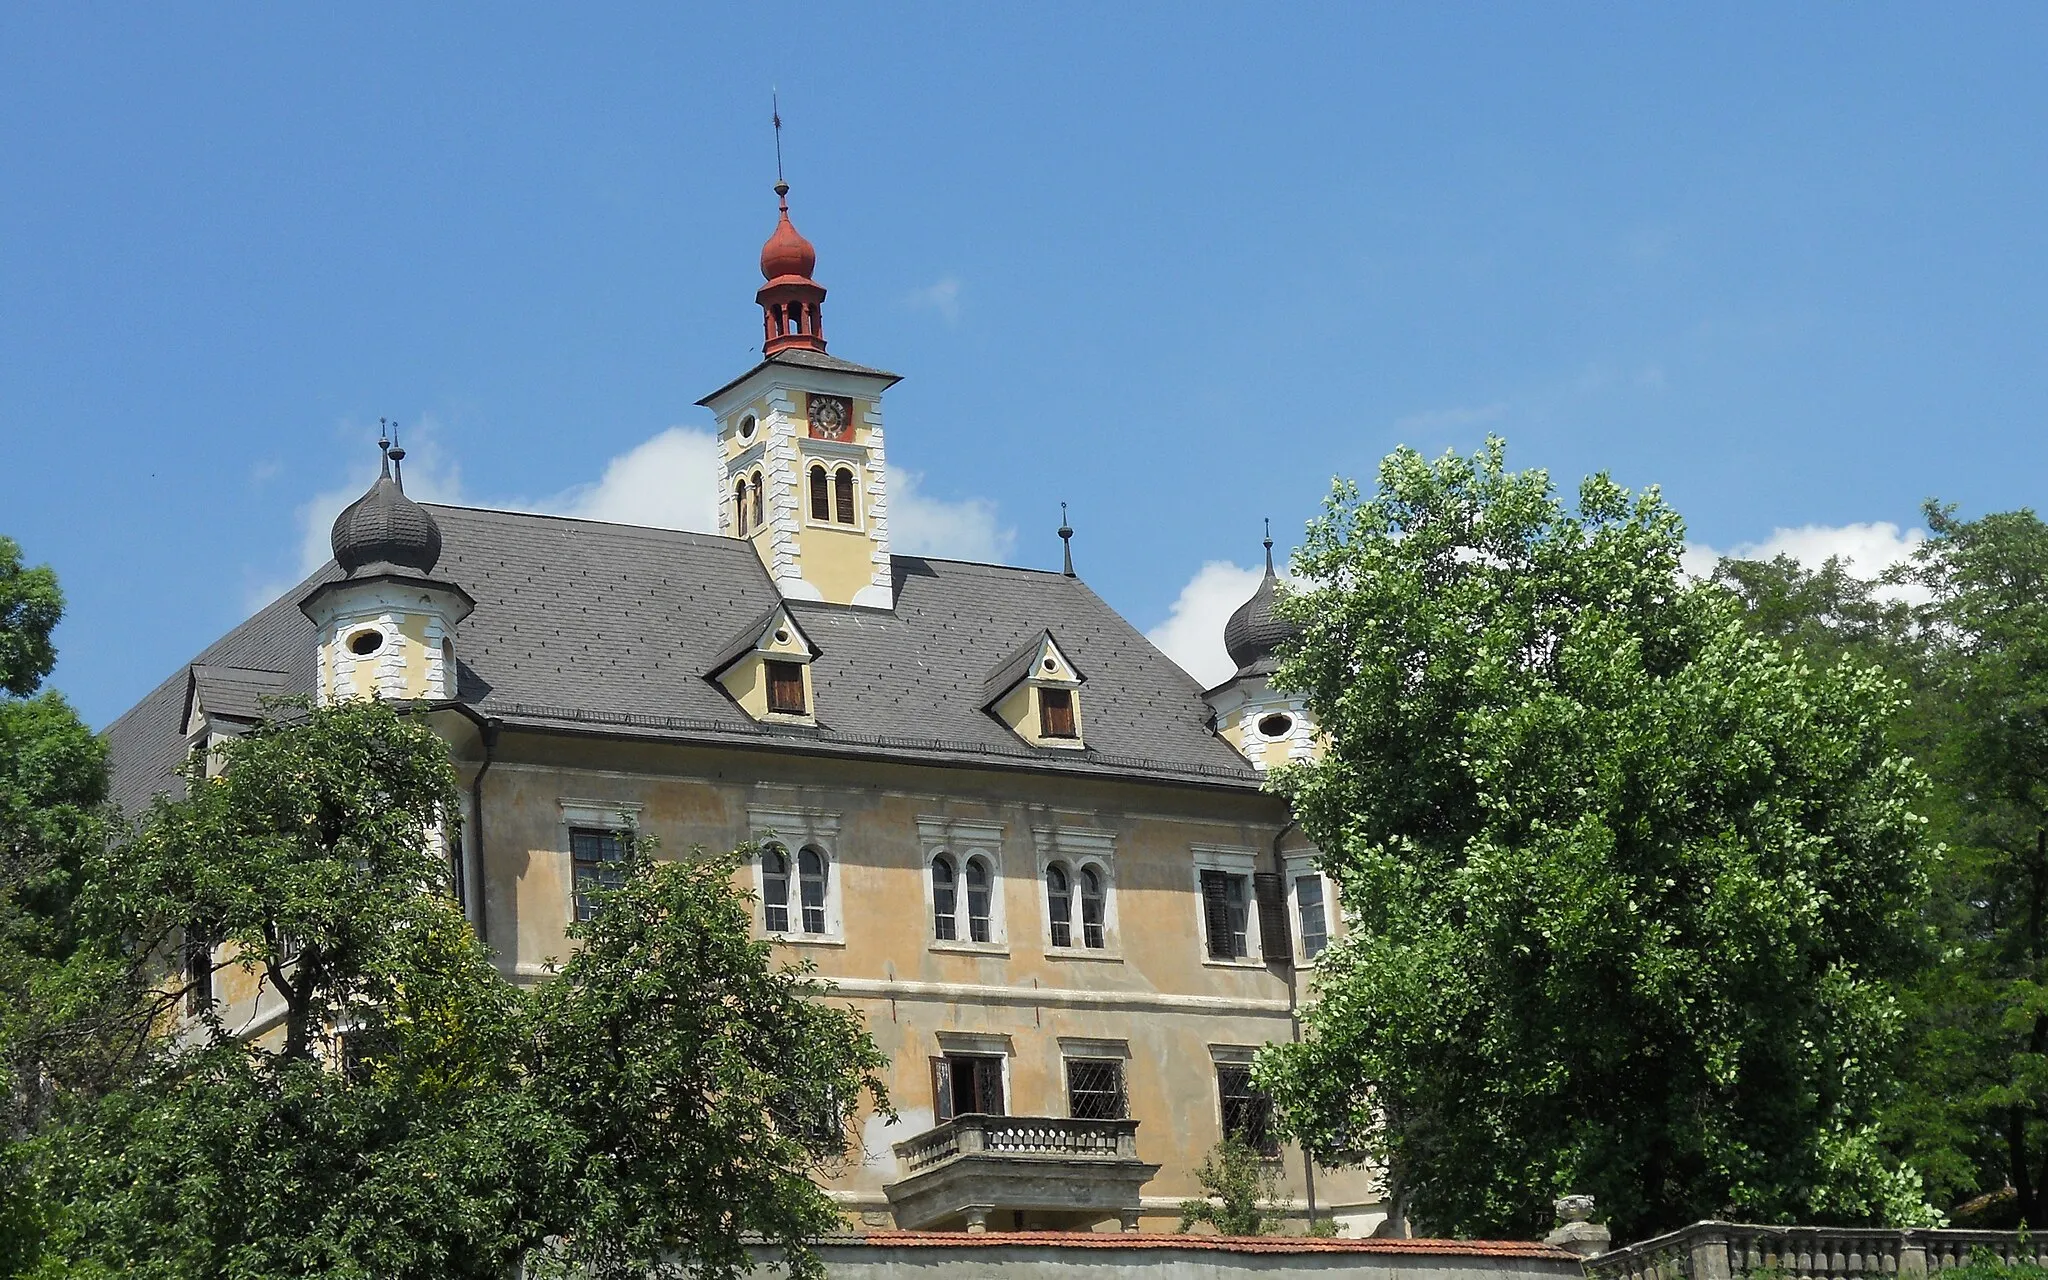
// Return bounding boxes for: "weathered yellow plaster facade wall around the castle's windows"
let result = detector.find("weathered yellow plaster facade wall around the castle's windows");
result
[468,733,1378,1231]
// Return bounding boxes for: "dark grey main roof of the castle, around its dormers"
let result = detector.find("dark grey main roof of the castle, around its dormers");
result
[106,506,1260,811]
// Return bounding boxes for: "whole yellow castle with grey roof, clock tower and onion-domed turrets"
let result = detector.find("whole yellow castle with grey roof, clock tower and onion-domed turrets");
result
[109,182,1384,1235]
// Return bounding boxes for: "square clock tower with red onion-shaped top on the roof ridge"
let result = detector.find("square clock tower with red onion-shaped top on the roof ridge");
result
[696,182,899,608]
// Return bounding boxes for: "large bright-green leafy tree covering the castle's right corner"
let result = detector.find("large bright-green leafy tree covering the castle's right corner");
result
[1260,440,1925,1237]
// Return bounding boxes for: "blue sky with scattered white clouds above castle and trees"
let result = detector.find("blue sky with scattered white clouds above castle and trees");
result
[0,4,2048,723]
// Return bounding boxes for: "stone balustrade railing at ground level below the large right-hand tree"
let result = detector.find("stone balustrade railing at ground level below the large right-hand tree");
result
[1585,1223,2048,1280]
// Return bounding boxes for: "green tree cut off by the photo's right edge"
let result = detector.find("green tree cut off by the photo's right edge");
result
[1888,502,2048,1227]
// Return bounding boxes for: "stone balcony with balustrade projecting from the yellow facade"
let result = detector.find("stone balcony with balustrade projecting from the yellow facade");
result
[883,1116,1159,1233]
